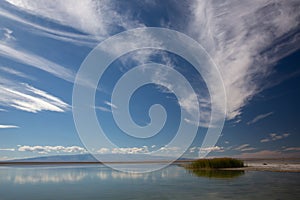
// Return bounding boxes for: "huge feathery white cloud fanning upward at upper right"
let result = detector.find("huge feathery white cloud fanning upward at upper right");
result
[189,0,300,119]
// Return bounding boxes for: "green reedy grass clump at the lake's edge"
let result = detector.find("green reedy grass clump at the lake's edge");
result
[187,158,244,169]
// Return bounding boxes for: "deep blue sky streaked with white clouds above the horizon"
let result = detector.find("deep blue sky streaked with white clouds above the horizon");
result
[0,0,300,160]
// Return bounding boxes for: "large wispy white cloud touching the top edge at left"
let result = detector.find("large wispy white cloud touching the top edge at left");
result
[4,0,143,43]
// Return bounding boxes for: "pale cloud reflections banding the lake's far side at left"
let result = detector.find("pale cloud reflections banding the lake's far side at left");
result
[0,166,182,184]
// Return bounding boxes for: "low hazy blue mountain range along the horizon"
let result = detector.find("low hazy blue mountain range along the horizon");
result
[6,154,188,162]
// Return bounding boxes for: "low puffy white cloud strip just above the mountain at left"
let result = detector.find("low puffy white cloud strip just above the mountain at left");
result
[18,145,87,154]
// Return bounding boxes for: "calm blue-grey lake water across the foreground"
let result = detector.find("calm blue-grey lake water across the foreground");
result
[0,165,300,200]
